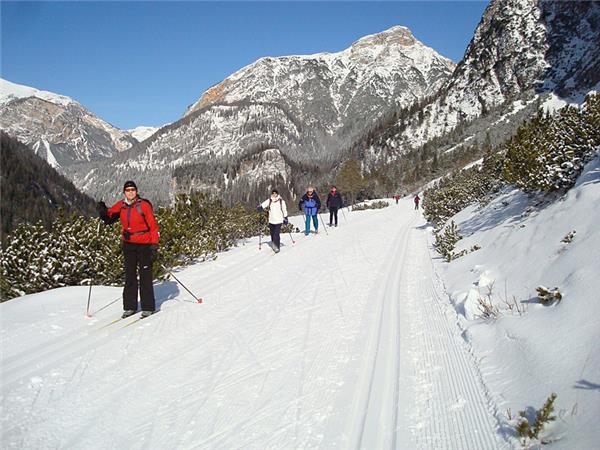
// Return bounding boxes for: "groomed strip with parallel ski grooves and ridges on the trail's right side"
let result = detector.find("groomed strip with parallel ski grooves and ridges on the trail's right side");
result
[344,215,508,450]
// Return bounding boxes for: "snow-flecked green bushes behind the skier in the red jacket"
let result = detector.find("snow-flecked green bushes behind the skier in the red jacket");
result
[0,194,262,301]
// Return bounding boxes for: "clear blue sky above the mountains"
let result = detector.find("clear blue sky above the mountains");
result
[0,0,488,129]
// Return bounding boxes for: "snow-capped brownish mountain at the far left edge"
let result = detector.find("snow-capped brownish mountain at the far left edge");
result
[0,79,136,169]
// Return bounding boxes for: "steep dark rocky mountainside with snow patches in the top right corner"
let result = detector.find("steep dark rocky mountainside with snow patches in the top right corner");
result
[373,0,600,153]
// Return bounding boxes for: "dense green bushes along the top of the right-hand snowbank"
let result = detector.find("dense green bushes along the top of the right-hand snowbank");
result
[423,94,600,224]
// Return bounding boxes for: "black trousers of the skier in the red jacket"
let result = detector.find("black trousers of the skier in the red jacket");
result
[123,242,156,311]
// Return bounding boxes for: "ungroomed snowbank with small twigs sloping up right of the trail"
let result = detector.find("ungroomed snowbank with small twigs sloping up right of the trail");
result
[443,156,600,449]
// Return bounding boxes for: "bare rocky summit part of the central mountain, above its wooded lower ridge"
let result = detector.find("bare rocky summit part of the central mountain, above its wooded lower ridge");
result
[185,26,455,116]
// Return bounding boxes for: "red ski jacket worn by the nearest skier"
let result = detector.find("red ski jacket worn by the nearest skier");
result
[108,197,159,244]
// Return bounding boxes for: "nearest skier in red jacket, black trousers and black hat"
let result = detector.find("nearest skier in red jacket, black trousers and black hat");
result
[97,181,159,318]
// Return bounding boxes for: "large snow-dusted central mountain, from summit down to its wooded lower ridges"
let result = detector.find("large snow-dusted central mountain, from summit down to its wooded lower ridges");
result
[72,26,455,202]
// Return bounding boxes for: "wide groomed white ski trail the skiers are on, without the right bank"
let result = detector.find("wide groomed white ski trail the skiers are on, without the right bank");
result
[0,200,510,450]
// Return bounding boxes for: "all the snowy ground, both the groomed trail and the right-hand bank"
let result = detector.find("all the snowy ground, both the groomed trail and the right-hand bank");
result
[0,154,600,449]
